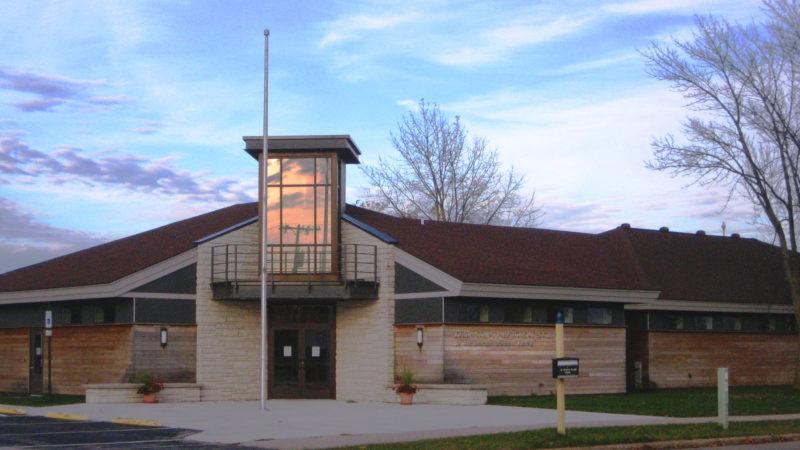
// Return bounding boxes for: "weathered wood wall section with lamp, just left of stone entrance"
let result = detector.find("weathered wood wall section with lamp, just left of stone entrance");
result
[133,325,197,383]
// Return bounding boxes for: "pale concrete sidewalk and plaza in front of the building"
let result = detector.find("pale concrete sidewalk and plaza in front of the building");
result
[6,400,800,448]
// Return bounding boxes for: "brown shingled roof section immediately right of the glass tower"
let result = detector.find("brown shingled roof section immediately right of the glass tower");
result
[346,205,657,290]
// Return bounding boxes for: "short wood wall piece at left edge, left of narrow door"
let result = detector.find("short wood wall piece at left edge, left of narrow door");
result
[0,328,30,392]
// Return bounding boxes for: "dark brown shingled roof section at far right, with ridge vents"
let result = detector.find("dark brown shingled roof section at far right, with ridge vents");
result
[604,227,791,304]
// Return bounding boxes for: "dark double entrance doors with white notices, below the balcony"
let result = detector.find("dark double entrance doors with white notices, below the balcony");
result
[269,304,334,398]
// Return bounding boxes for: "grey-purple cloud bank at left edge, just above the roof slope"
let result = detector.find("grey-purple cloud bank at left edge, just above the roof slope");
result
[0,197,104,273]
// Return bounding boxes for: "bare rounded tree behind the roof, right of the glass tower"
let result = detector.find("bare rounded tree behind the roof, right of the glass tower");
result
[362,100,541,226]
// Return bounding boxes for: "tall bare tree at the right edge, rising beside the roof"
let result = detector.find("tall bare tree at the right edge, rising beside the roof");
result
[643,0,800,387]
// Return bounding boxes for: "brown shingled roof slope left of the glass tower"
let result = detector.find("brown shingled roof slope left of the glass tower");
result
[0,203,258,292]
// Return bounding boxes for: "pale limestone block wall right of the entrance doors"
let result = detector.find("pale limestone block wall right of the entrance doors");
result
[336,222,395,401]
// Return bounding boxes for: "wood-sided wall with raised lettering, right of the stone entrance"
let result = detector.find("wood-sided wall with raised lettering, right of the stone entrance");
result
[395,325,625,395]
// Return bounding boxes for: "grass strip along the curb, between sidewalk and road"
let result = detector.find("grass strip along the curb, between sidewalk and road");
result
[346,420,800,449]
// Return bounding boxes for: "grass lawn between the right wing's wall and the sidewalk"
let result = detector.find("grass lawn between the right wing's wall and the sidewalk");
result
[489,386,800,417]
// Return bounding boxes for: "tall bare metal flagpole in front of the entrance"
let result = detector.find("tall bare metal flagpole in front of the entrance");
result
[260,30,269,411]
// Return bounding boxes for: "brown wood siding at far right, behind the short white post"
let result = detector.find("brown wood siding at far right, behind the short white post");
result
[645,331,798,388]
